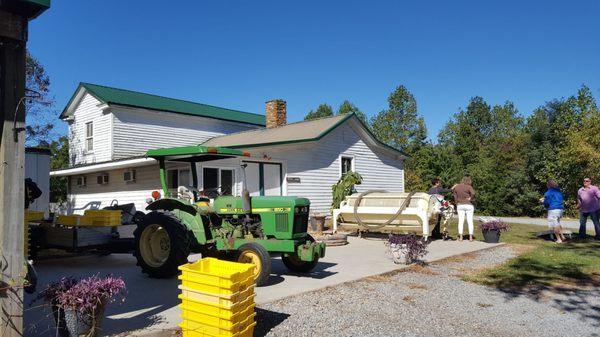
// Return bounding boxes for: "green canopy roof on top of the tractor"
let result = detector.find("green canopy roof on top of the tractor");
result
[146,145,250,163]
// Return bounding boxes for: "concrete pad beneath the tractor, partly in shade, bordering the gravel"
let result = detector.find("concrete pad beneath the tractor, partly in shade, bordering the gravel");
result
[25,237,502,337]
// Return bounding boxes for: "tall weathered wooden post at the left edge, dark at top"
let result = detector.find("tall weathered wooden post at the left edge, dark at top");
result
[0,0,50,337]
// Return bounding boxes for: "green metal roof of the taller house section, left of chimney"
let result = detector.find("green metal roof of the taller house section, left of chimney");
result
[60,83,265,126]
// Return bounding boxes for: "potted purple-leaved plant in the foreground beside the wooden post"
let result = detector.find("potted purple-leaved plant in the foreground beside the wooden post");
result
[38,276,125,337]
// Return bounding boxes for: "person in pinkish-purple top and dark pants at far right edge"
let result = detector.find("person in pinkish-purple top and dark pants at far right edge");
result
[577,178,600,240]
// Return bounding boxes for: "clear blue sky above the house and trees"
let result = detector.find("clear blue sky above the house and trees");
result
[28,0,600,138]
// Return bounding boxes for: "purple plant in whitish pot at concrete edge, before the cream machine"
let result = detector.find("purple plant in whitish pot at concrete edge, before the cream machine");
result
[386,233,429,264]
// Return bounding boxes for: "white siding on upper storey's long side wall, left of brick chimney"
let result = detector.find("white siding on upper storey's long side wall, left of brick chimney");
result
[113,109,257,159]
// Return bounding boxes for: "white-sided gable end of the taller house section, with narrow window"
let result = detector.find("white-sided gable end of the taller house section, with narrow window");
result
[69,93,112,165]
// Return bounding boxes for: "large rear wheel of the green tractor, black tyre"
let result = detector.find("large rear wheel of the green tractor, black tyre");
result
[133,211,190,278]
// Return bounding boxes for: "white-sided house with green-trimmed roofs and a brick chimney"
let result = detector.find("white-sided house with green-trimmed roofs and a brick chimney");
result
[51,83,404,213]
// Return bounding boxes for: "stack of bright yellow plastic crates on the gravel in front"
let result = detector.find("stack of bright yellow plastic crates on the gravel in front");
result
[179,258,256,337]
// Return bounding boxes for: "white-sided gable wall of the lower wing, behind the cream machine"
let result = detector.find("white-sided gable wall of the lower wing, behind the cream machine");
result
[238,123,404,214]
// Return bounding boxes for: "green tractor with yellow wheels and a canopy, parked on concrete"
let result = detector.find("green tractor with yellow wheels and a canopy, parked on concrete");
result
[134,145,325,286]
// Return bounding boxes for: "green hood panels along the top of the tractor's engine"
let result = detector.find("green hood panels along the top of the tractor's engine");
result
[214,196,310,214]
